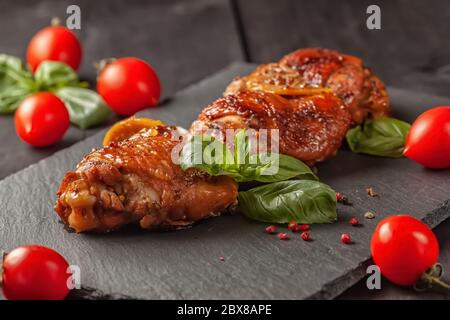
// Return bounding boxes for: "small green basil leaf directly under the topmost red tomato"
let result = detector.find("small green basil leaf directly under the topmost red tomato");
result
[34,61,79,91]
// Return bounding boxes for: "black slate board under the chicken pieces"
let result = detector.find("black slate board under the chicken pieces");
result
[0,64,450,299]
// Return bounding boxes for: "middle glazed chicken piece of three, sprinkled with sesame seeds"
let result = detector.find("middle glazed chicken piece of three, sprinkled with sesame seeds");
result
[191,91,351,165]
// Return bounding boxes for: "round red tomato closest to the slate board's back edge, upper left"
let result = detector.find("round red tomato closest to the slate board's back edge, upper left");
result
[97,58,161,116]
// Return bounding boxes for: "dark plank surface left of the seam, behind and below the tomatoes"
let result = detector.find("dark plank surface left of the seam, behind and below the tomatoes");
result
[0,0,243,179]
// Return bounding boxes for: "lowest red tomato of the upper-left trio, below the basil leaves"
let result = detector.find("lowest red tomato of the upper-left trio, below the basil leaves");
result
[14,92,70,147]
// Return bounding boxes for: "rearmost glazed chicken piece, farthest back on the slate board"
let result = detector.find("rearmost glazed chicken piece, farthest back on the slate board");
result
[225,49,390,124]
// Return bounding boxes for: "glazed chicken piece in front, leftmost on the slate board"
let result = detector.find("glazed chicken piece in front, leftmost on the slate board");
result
[55,127,237,232]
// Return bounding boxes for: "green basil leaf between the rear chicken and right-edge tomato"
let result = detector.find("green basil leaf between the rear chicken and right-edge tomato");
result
[346,117,411,158]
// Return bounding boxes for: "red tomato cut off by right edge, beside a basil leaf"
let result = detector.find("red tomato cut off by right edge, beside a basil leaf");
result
[403,107,450,169]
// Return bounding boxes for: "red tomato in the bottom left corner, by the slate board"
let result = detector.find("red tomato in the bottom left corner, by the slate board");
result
[3,245,70,300]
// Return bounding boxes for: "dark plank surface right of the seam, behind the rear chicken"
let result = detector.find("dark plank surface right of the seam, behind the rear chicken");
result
[236,0,450,96]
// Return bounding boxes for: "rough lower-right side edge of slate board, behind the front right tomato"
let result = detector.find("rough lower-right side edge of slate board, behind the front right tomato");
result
[306,199,450,300]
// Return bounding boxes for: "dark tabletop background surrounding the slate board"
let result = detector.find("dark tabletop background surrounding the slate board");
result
[0,0,450,299]
